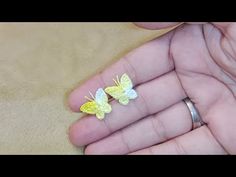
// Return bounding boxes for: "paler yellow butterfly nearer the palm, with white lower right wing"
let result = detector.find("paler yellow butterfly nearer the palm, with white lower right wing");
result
[105,73,138,105]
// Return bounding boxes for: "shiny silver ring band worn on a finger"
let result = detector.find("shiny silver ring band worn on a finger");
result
[183,98,205,129]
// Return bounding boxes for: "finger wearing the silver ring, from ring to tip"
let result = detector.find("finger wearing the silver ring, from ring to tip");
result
[85,101,192,154]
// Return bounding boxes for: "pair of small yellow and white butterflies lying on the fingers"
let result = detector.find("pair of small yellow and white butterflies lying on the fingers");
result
[80,73,138,119]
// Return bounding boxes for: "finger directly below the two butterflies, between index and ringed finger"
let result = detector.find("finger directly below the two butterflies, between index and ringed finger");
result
[70,72,186,146]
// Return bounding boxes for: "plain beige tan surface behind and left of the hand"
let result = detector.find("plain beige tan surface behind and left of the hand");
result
[0,23,166,154]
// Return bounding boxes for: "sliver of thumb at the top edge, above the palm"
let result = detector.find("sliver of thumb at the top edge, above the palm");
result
[134,22,178,30]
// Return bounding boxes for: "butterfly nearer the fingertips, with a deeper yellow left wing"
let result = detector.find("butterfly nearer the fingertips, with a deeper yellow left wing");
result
[80,88,112,120]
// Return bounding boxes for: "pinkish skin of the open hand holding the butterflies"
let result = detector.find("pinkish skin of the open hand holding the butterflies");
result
[69,23,236,154]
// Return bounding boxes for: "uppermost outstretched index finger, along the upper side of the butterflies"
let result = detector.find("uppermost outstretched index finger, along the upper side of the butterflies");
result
[69,33,174,111]
